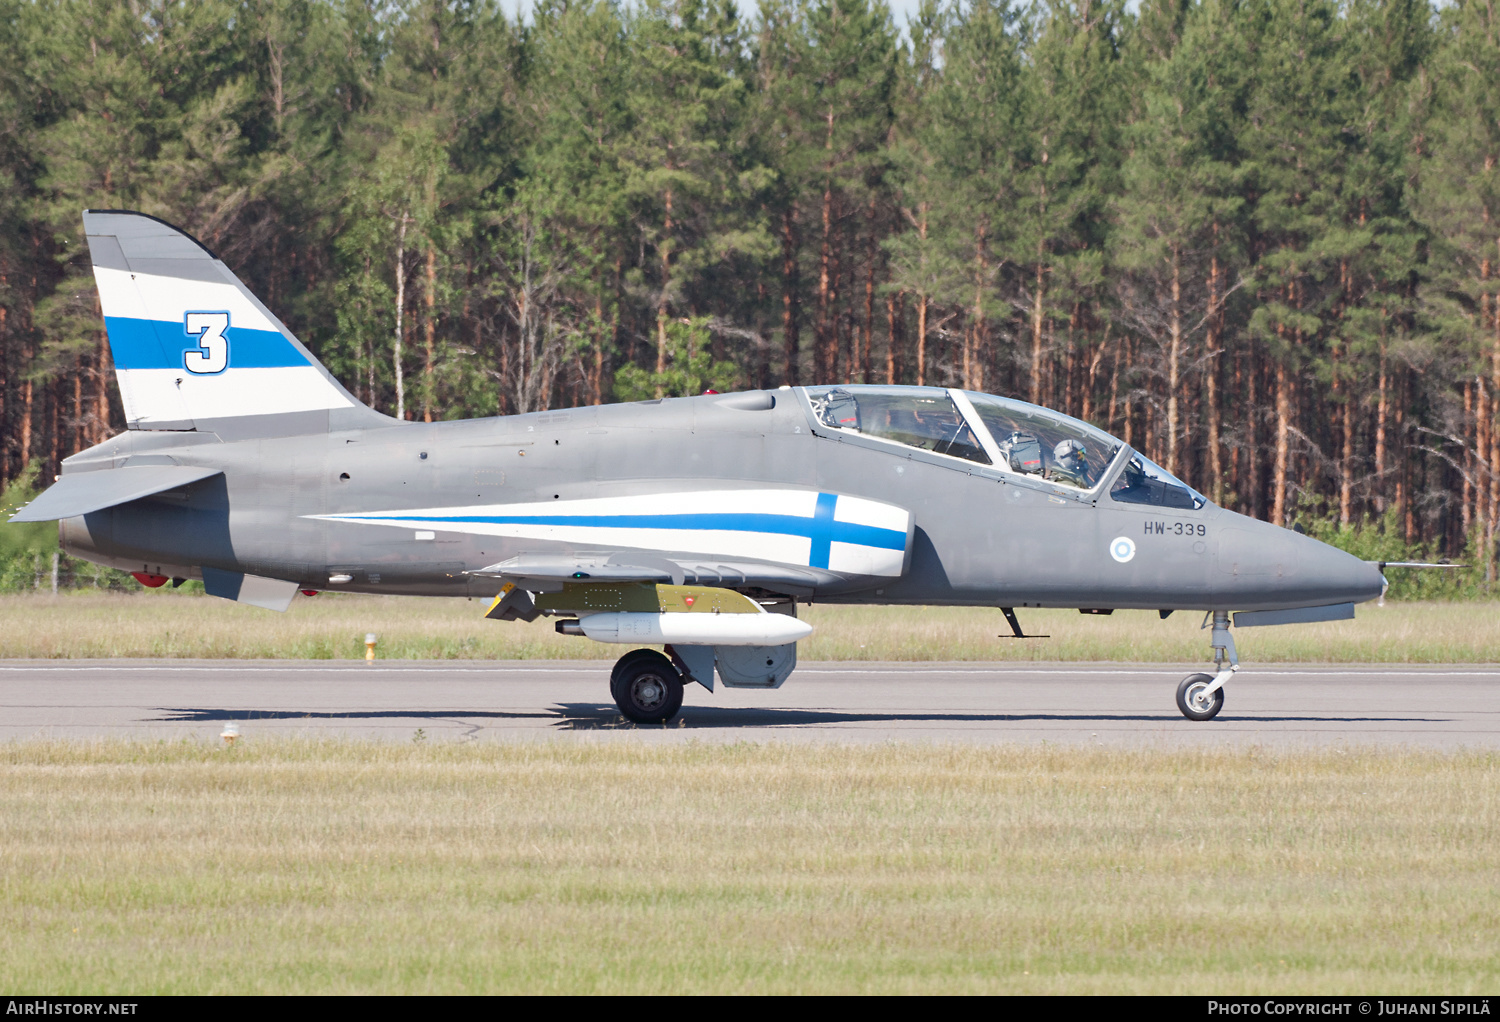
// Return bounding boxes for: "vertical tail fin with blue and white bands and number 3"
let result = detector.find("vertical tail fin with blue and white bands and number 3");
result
[84,210,393,438]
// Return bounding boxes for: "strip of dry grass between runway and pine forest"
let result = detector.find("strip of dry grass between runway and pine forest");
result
[0,593,1500,663]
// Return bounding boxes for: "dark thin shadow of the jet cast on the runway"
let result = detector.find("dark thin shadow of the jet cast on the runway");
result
[156,702,1446,731]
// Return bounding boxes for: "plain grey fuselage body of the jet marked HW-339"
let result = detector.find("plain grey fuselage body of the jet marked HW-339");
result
[60,390,1383,611]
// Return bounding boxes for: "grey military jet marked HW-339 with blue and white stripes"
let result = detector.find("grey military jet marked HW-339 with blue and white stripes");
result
[12,210,1385,722]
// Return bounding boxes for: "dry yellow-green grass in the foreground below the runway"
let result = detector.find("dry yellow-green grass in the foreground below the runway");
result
[0,741,1500,993]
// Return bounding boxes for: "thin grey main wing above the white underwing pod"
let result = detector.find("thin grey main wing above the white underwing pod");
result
[470,551,849,594]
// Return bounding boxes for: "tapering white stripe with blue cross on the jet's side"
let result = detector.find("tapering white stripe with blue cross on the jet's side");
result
[312,489,912,578]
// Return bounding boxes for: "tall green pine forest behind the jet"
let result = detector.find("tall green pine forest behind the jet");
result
[0,0,1500,579]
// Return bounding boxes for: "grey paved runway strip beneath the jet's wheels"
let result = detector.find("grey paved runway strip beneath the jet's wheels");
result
[0,660,1500,749]
